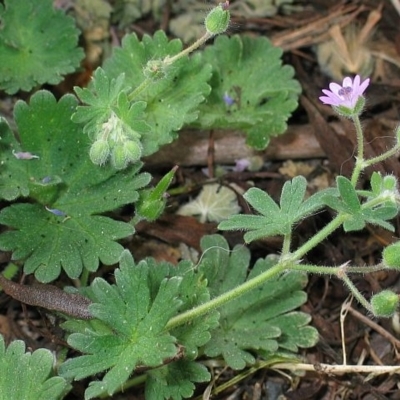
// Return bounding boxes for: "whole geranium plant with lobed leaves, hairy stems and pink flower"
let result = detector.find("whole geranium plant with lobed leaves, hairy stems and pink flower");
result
[0,0,400,400]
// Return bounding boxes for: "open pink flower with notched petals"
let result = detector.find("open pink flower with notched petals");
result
[319,75,369,109]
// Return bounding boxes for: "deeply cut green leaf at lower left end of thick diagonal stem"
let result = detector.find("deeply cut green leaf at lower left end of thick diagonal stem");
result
[60,265,180,399]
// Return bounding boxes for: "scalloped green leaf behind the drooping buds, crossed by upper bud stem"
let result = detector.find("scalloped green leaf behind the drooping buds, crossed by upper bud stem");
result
[104,31,211,155]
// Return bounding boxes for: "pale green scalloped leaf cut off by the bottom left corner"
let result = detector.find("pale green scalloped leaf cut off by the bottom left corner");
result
[0,335,70,400]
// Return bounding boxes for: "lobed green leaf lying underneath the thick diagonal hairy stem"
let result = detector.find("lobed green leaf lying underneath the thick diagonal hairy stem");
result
[199,235,318,369]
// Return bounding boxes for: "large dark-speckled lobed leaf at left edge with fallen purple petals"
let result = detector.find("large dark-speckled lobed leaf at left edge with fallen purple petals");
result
[0,91,150,282]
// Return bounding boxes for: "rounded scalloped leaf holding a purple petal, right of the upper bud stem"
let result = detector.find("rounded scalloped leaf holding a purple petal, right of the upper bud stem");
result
[193,35,301,150]
